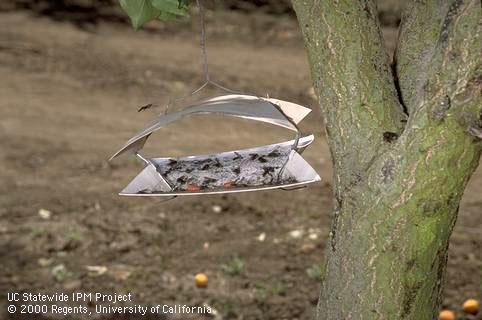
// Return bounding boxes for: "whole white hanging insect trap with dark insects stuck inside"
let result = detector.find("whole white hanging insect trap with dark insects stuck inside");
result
[111,95,320,196]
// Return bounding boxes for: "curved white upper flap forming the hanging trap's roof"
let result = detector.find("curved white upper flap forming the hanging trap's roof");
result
[110,94,311,160]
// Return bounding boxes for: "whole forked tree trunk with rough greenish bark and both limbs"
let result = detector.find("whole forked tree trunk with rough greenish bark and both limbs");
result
[292,0,482,320]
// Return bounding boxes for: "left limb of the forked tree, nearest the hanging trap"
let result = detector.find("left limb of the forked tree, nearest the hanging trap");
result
[292,0,406,192]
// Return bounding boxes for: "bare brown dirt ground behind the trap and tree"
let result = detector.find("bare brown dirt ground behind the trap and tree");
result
[0,5,482,320]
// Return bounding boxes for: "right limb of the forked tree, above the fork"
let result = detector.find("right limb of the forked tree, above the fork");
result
[396,0,482,130]
